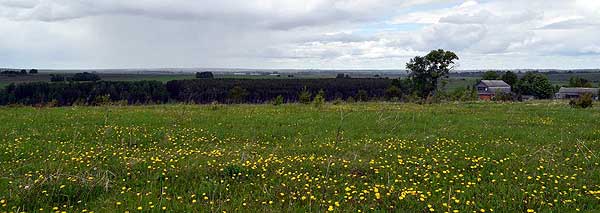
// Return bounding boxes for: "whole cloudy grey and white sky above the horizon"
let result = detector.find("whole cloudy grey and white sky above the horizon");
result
[0,0,600,70]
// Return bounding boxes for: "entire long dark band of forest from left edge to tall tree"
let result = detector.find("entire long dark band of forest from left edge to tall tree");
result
[0,79,392,106]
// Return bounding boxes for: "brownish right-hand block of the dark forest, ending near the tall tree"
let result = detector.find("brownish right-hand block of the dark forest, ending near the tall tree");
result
[166,79,391,103]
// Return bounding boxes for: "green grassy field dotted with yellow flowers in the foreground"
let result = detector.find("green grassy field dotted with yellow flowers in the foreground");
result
[0,102,600,212]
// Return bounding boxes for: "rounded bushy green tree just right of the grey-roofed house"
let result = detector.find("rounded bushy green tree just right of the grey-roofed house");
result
[515,72,555,99]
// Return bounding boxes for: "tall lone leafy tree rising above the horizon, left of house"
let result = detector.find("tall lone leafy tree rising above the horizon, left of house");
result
[406,49,459,98]
